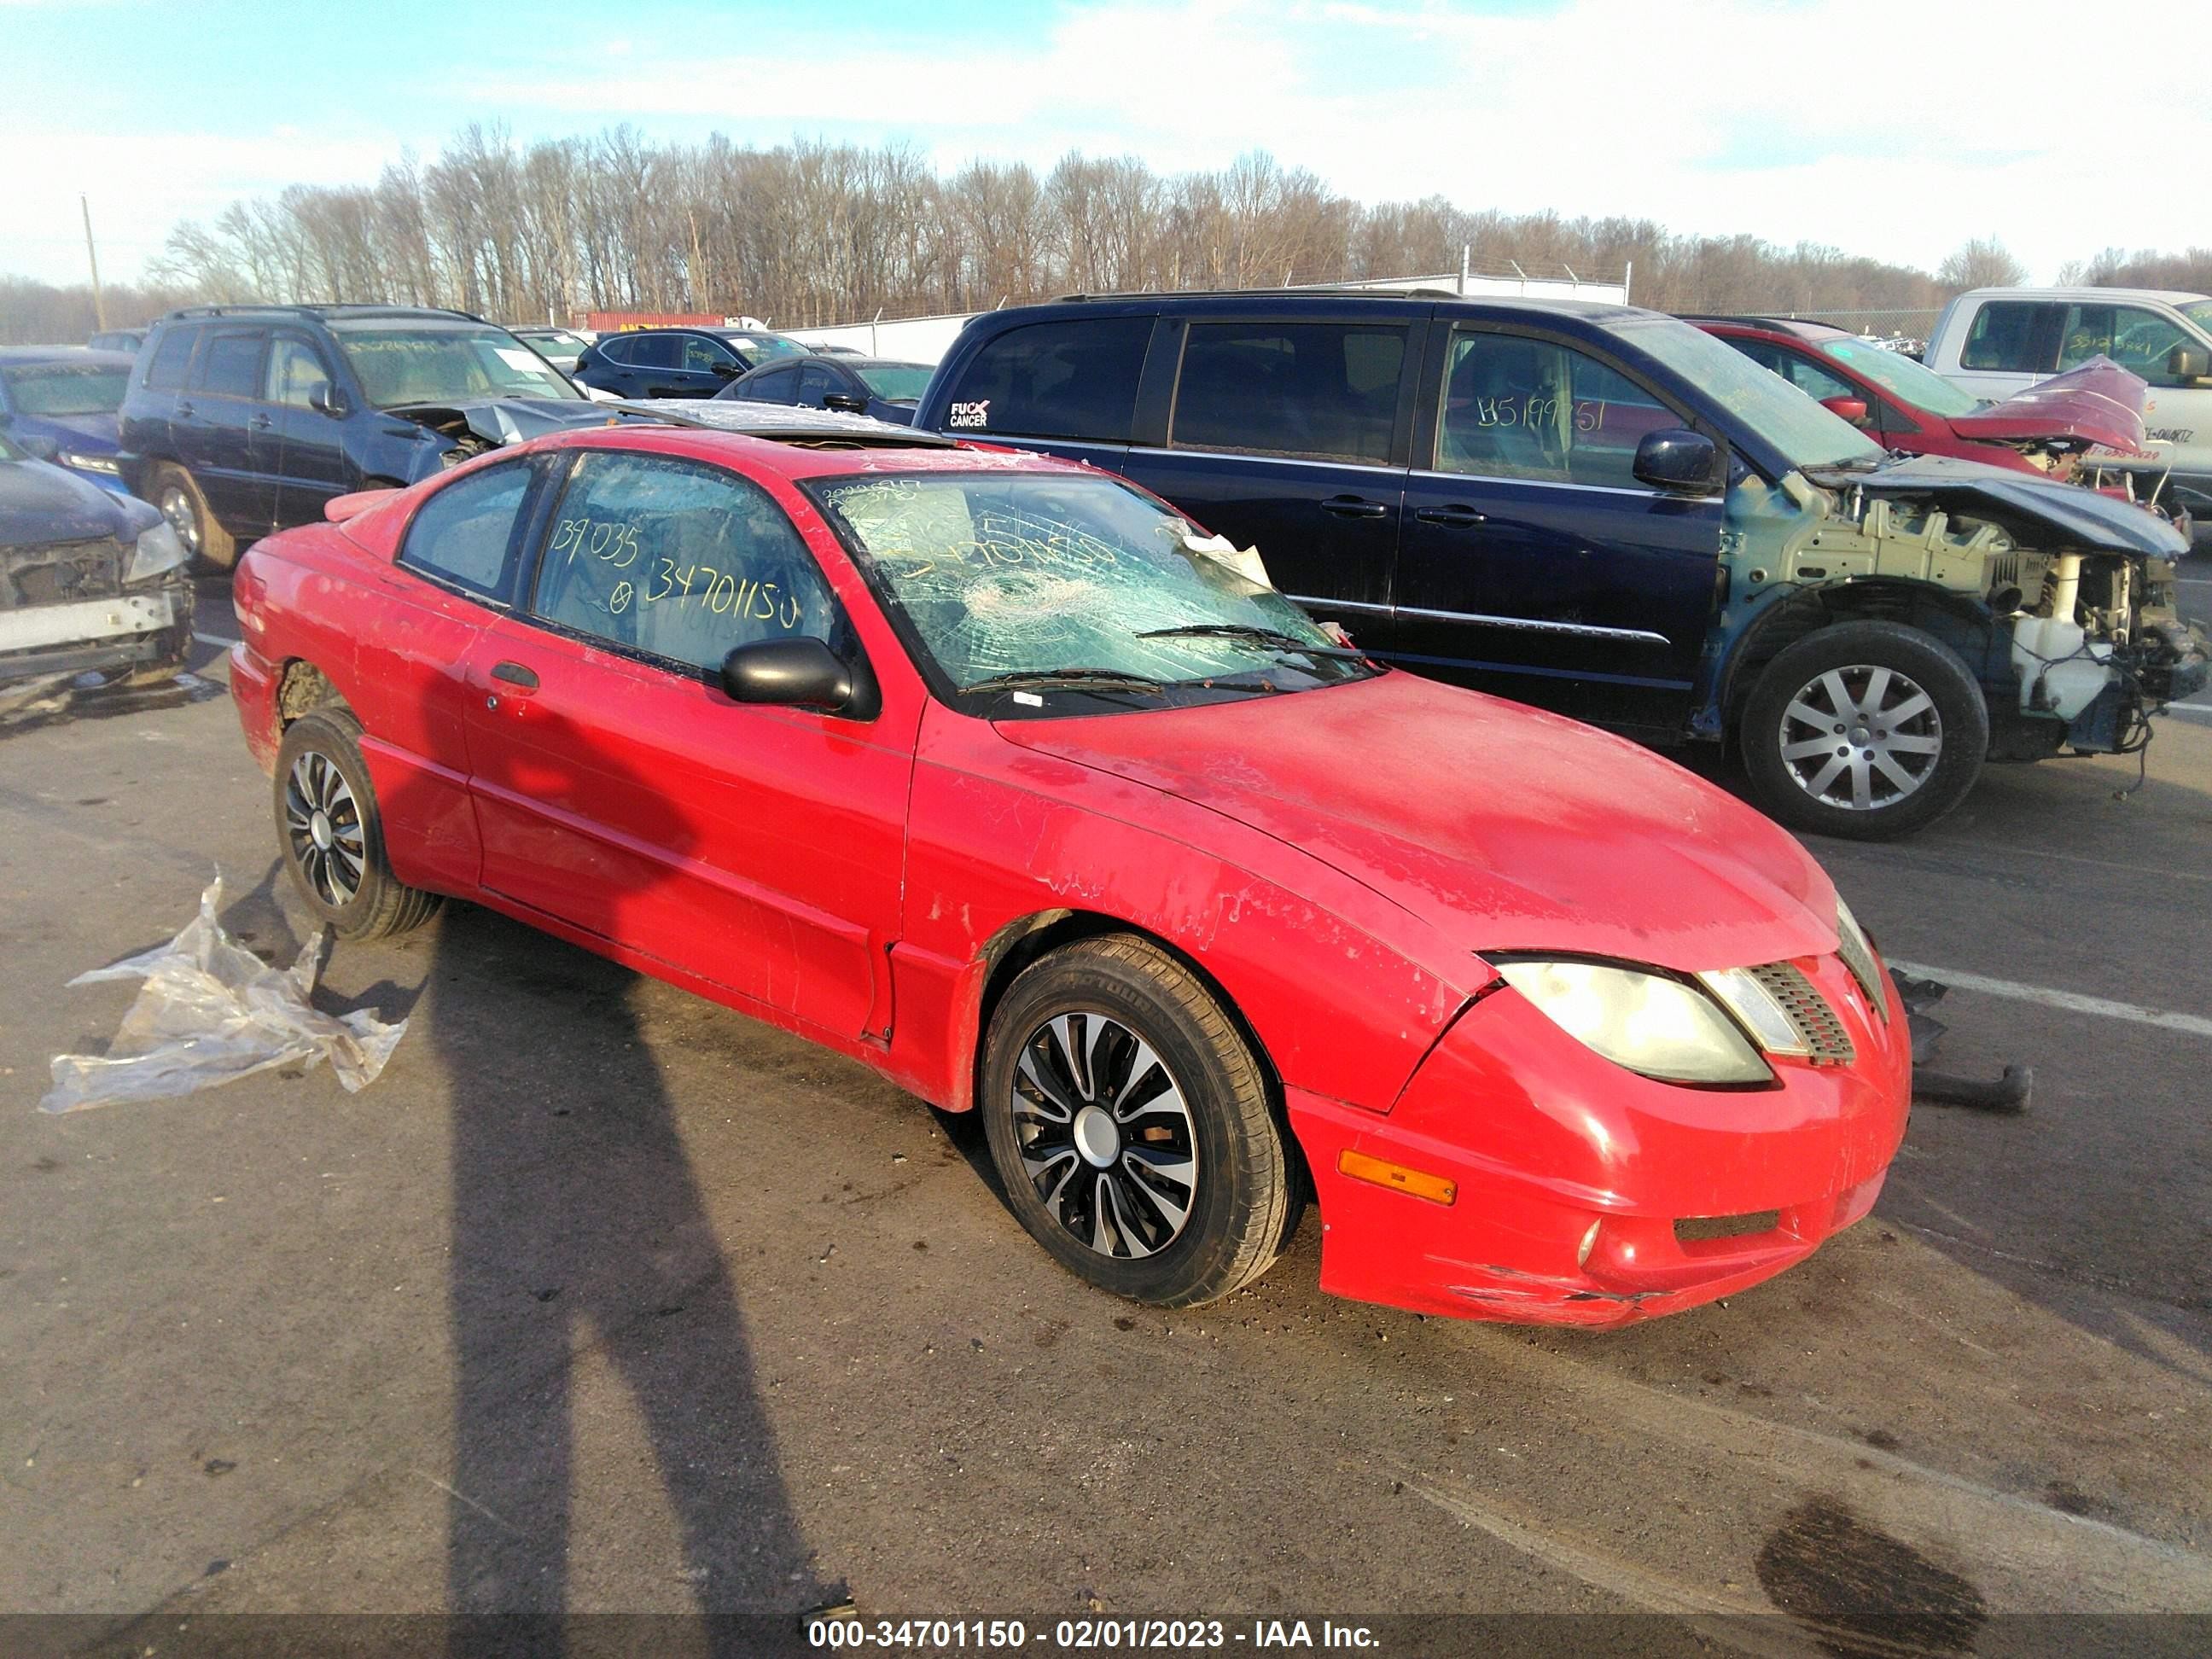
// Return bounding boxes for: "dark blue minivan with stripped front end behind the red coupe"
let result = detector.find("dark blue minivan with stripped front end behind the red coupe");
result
[916,290,2208,838]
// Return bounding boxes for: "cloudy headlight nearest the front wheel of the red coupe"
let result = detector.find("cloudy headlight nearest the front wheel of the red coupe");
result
[1498,960,1774,1084]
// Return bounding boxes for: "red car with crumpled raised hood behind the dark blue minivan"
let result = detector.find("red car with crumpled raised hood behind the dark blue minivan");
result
[1688,317,2150,493]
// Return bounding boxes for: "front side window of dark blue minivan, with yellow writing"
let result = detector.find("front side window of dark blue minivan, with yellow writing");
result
[1435,328,1684,489]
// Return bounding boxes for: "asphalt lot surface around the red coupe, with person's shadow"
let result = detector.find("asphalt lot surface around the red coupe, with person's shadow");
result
[0,560,2212,1652]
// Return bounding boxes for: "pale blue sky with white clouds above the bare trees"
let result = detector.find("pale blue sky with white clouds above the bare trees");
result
[0,0,2212,292]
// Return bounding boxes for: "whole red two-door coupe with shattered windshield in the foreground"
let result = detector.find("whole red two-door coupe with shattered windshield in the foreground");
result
[232,427,1911,1325]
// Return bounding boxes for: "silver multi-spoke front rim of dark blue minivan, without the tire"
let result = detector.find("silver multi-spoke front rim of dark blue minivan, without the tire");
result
[1778,664,1942,812]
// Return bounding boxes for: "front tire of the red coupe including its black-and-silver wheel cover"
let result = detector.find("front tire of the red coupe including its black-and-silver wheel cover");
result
[982,934,1299,1307]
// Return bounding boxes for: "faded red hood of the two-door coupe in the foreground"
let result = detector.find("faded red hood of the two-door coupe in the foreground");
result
[998,672,1836,971]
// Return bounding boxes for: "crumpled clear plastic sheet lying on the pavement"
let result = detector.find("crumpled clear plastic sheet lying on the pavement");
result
[38,876,407,1113]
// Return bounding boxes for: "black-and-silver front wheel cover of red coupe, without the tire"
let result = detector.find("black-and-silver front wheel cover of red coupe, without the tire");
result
[1013,1013,1199,1260]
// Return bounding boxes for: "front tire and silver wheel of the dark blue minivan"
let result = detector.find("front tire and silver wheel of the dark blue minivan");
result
[1738,621,1988,841]
